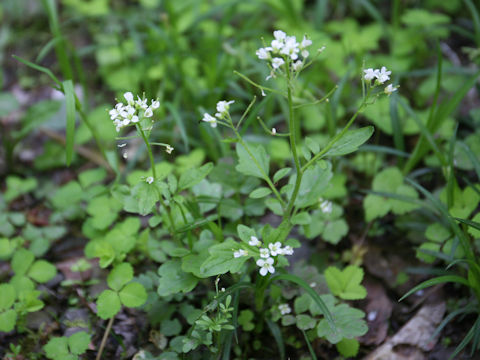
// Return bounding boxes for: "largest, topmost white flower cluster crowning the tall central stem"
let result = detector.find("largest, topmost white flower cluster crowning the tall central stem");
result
[256,30,312,80]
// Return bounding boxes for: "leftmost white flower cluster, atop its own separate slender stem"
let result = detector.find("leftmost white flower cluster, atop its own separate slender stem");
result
[109,92,160,132]
